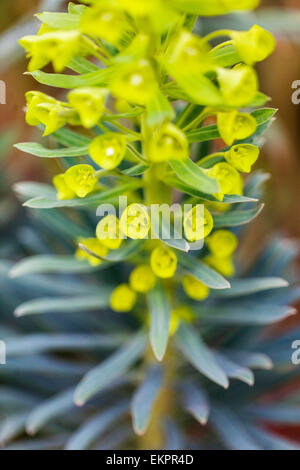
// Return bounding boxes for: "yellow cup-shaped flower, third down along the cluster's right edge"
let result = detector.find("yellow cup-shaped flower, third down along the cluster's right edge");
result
[217,111,257,145]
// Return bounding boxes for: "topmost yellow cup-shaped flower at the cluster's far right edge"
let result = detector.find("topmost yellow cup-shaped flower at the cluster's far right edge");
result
[231,24,276,65]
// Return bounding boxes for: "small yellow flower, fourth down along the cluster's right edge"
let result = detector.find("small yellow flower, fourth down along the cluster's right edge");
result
[224,144,259,173]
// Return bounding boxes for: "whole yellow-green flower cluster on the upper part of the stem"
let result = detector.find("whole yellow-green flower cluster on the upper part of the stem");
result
[20,0,275,328]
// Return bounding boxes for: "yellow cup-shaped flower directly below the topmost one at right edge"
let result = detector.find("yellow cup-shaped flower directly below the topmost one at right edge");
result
[217,65,258,108]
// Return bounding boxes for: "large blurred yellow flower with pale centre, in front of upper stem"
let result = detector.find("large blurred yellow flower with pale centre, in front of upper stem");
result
[110,59,157,105]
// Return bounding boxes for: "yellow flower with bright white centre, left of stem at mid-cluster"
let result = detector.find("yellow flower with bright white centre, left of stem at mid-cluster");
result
[89,132,126,170]
